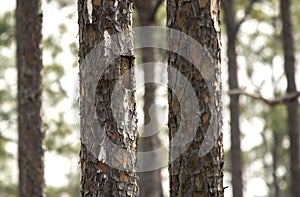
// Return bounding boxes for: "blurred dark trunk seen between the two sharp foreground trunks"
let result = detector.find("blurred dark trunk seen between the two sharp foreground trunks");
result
[135,0,163,197]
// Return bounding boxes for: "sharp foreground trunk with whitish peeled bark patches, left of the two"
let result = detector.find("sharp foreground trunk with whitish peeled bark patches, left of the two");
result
[78,0,138,196]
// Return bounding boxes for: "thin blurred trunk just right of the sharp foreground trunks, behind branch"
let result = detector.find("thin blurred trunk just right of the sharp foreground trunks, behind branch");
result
[222,0,243,197]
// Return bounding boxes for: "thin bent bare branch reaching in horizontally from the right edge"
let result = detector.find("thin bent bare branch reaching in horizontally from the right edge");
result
[228,89,300,106]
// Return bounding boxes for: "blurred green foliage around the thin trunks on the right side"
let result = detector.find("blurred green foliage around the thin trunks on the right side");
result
[221,0,300,196]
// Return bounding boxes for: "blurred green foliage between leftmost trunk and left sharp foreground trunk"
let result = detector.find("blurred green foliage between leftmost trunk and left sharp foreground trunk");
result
[43,0,80,194]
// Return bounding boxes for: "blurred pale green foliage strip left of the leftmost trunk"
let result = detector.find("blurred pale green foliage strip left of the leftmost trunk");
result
[0,12,17,197]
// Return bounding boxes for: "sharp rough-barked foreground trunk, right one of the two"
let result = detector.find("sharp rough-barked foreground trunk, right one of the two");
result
[167,0,224,197]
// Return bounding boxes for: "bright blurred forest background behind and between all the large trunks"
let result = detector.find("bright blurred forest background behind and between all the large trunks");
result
[0,0,300,197]
